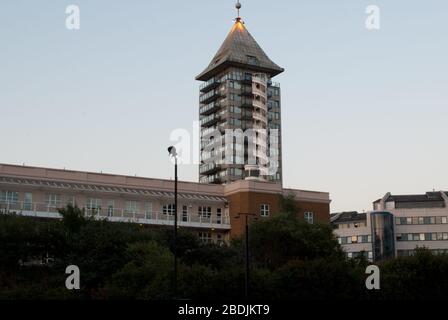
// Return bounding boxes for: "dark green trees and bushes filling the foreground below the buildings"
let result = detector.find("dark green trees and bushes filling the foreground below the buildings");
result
[0,205,448,301]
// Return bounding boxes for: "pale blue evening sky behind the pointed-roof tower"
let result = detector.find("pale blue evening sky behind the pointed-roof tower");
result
[0,0,448,212]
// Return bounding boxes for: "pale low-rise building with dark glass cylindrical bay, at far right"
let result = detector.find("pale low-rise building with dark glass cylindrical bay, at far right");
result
[331,191,448,260]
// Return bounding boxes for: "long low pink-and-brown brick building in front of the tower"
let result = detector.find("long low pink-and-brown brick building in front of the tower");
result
[0,164,330,242]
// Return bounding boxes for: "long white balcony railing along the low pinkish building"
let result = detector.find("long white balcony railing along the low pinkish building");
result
[0,202,230,229]
